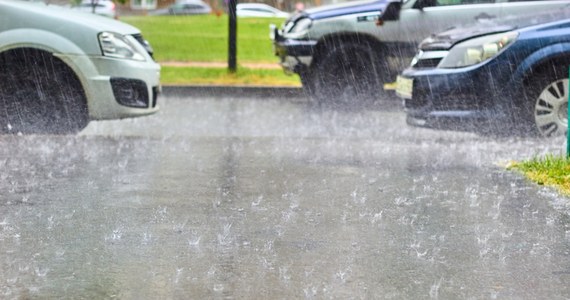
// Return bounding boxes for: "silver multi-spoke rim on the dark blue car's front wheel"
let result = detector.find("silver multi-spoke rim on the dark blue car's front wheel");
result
[534,79,568,137]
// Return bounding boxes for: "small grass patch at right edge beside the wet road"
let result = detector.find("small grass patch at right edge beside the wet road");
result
[508,155,570,196]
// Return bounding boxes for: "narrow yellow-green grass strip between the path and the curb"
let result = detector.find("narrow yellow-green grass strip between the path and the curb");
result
[160,67,301,87]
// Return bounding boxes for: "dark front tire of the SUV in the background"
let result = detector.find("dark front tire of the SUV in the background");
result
[312,42,386,107]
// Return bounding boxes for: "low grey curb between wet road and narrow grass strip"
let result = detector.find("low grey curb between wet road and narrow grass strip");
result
[162,85,305,98]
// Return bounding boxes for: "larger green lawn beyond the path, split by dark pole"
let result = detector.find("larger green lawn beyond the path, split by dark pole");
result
[121,15,283,63]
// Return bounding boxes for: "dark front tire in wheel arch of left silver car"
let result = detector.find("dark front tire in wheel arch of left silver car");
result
[0,49,89,134]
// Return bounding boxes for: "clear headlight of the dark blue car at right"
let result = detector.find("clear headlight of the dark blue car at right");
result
[438,32,519,68]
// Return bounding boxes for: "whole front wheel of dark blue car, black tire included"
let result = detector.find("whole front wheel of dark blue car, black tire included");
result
[514,65,568,137]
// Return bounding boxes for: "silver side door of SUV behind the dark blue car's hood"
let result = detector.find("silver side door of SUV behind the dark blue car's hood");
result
[399,0,501,43]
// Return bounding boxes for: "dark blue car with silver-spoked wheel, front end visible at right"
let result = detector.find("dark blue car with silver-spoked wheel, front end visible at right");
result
[396,10,570,136]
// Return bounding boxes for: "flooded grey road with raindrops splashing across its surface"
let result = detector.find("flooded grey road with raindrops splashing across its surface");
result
[0,97,570,299]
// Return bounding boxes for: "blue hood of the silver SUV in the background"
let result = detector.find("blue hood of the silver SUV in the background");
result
[300,0,393,20]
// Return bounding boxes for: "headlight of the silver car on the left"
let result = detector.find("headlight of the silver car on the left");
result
[99,32,145,61]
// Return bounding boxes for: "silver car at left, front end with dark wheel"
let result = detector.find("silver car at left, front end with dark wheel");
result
[0,0,160,133]
